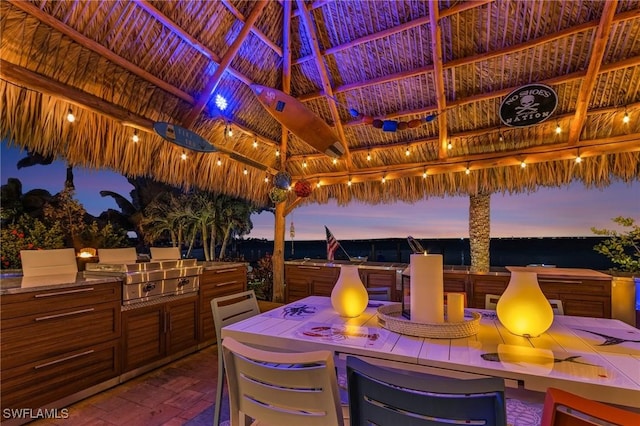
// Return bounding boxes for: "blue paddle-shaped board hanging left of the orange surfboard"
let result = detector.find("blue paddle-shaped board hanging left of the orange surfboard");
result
[153,122,277,174]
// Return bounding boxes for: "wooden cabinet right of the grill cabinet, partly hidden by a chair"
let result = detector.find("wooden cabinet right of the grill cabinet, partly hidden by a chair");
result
[199,264,247,345]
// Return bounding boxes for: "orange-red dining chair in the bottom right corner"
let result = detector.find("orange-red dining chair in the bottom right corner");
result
[541,388,640,426]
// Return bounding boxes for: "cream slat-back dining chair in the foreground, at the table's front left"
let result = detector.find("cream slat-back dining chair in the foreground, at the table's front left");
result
[222,337,344,426]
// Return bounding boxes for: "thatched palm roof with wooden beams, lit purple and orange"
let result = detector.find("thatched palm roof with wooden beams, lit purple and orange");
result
[0,0,640,203]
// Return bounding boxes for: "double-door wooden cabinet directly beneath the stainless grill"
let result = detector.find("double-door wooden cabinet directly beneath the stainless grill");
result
[122,295,199,372]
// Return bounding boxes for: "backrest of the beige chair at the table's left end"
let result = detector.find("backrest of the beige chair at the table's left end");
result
[211,290,260,349]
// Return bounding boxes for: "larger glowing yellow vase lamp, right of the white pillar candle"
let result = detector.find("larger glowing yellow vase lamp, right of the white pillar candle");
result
[496,271,553,337]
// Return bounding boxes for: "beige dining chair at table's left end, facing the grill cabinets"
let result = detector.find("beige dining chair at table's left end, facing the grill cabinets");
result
[211,290,260,426]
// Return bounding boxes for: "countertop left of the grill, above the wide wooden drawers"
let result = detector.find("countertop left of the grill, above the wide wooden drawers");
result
[0,272,121,296]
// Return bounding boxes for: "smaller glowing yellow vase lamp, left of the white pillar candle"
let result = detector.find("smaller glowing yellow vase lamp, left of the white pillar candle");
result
[331,265,369,318]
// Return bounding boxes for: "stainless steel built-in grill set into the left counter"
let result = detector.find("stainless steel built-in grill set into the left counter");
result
[84,259,202,305]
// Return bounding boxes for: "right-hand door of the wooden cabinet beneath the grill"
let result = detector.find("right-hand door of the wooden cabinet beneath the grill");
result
[165,296,198,355]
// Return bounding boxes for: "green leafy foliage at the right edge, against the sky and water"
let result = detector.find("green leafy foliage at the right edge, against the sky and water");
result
[591,216,640,272]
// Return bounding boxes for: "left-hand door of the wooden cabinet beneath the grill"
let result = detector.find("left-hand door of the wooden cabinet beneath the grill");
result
[122,303,166,371]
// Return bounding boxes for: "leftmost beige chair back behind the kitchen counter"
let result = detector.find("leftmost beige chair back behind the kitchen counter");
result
[20,248,78,277]
